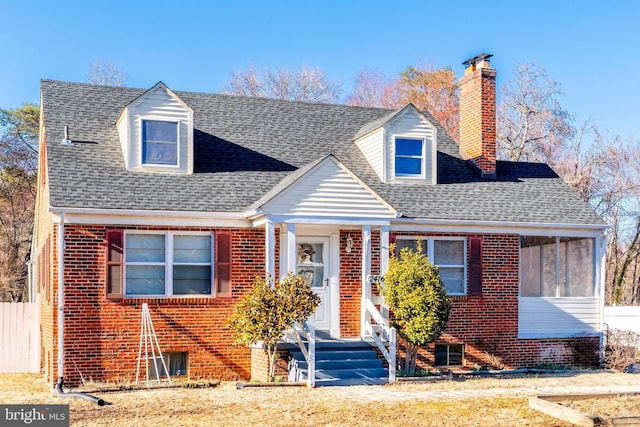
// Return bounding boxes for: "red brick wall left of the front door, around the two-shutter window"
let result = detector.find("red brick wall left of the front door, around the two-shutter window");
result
[42,225,265,385]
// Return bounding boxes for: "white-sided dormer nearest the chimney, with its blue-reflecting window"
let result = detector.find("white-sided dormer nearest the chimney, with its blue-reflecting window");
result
[354,104,437,184]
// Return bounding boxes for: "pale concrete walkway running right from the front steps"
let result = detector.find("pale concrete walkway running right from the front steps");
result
[330,385,640,402]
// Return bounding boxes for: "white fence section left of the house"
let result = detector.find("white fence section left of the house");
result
[0,302,40,373]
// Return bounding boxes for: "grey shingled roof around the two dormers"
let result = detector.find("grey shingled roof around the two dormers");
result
[41,80,603,226]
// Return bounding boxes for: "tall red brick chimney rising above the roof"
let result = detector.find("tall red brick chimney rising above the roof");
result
[460,53,496,178]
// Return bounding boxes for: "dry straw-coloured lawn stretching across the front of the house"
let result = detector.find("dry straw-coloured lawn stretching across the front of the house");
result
[0,373,640,426]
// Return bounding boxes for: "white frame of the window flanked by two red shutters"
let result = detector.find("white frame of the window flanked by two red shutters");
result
[122,230,216,298]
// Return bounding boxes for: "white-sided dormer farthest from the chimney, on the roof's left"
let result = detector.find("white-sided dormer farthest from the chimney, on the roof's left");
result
[116,82,193,174]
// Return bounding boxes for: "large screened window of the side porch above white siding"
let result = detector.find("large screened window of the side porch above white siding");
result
[520,236,595,297]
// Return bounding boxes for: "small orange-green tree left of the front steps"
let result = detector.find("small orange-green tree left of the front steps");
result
[229,273,320,382]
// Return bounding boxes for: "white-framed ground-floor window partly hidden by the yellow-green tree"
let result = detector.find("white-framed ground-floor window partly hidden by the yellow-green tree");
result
[396,236,467,295]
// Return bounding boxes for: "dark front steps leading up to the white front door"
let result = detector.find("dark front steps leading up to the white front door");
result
[289,340,389,387]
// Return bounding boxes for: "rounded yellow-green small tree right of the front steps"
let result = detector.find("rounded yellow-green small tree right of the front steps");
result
[382,241,451,373]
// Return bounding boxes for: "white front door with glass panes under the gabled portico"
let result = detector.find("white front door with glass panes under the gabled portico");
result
[296,237,335,331]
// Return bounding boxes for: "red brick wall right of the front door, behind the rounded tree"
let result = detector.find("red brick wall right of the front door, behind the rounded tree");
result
[392,233,598,369]
